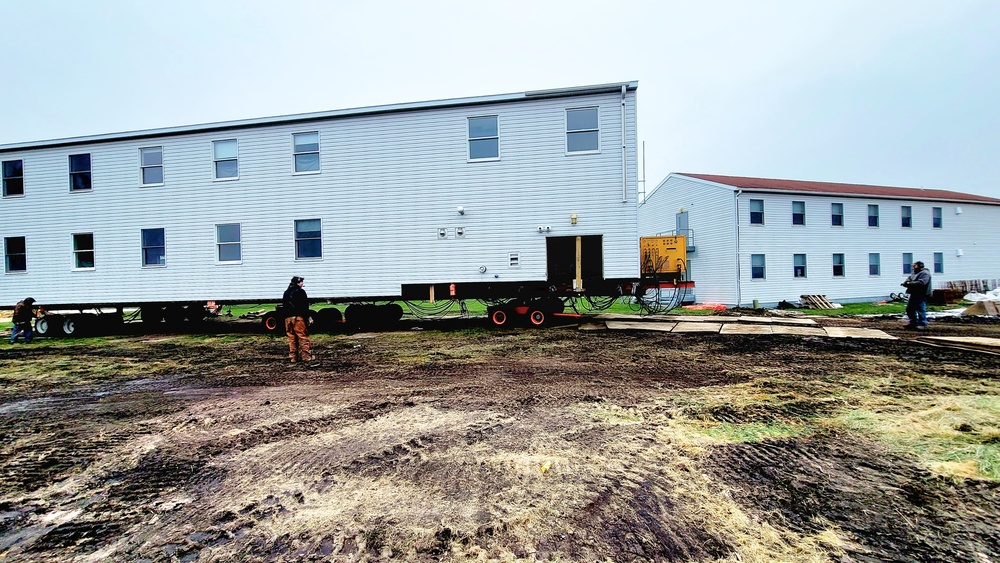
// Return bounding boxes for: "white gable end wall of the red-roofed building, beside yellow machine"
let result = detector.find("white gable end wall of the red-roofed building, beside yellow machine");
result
[639,175,737,304]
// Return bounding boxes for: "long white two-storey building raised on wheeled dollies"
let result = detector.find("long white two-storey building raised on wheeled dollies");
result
[0,82,688,333]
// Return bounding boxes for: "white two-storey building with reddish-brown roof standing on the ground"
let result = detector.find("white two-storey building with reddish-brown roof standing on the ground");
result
[639,173,1000,306]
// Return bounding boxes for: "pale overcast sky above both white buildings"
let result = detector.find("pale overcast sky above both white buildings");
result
[0,0,1000,198]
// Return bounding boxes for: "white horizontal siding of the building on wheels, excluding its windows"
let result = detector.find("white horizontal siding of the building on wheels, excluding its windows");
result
[0,89,638,304]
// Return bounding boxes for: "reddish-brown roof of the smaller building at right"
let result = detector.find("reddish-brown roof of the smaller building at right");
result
[676,172,1000,205]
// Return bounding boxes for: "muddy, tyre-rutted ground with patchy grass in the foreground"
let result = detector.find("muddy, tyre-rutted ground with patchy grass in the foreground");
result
[0,319,1000,563]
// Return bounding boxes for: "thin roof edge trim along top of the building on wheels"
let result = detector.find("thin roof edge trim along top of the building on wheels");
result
[0,80,639,153]
